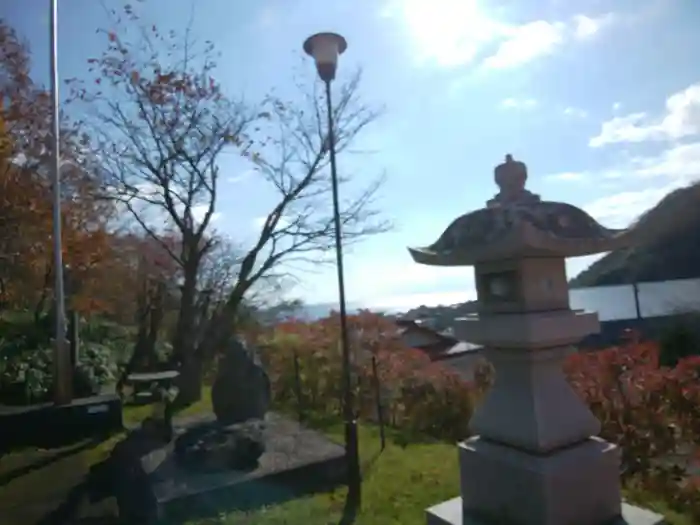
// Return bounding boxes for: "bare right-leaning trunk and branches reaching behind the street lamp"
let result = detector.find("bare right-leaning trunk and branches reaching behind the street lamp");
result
[198,71,391,380]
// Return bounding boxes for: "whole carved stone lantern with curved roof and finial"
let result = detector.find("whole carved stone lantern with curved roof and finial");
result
[409,155,663,525]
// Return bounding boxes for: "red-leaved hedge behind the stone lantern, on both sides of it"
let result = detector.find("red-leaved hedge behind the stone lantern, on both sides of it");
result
[263,312,700,522]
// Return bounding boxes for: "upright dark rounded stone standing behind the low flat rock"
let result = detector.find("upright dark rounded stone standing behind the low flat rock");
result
[211,339,270,426]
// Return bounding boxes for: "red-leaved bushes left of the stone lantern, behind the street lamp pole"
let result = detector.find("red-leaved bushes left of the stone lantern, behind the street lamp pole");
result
[260,312,472,440]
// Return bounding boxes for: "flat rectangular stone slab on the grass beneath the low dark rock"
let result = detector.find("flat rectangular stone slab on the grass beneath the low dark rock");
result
[108,412,347,525]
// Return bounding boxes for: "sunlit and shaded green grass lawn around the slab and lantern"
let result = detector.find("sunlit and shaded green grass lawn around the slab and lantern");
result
[0,391,692,525]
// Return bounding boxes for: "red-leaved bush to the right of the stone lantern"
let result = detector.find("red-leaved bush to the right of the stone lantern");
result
[565,339,700,520]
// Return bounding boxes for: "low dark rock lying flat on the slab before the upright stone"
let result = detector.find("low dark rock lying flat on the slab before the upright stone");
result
[175,420,265,471]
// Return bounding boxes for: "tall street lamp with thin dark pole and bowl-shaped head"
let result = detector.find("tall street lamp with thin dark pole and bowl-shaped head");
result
[304,33,361,503]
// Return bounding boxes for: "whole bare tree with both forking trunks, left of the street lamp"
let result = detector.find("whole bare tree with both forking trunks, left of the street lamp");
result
[74,7,388,402]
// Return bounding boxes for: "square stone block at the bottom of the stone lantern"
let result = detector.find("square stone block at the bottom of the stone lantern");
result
[459,437,621,525]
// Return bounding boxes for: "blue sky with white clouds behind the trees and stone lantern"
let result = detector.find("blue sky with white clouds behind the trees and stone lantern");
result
[0,0,700,307]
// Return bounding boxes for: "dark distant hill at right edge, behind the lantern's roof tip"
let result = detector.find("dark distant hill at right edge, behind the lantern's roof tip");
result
[570,182,700,288]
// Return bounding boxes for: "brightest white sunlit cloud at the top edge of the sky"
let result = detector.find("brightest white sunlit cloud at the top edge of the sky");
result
[381,0,612,69]
